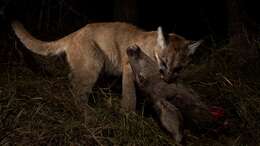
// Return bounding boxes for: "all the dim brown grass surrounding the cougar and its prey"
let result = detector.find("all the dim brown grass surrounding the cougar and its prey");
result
[0,32,260,146]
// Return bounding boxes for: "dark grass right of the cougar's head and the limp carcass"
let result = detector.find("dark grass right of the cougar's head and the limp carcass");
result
[183,42,260,145]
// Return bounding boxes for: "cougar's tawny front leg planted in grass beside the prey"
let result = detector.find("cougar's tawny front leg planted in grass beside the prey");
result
[121,63,136,112]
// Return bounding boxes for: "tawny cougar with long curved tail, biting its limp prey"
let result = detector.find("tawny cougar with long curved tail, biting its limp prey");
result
[12,21,201,111]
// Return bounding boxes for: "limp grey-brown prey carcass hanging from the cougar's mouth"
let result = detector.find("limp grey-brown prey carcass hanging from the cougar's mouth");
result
[127,45,223,141]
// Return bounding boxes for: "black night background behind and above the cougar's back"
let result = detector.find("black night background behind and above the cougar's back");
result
[0,0,260,68]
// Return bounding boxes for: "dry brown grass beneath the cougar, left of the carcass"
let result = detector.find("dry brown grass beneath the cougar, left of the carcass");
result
[0,65,177,145]
